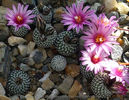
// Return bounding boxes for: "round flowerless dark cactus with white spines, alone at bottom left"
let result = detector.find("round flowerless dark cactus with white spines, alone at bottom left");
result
[6,70,30,95]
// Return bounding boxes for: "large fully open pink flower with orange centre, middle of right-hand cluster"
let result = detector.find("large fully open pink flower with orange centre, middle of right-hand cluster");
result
[82,24,118,55]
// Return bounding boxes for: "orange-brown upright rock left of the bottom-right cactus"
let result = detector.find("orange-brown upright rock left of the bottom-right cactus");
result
[68,80,82,98]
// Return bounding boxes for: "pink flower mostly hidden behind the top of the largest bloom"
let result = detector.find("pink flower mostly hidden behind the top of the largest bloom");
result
[92,13,119,29]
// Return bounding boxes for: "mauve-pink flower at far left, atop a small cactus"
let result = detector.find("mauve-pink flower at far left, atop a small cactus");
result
[6,3,35,31]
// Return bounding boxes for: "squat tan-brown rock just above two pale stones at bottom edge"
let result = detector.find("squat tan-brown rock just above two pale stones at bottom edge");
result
[42,78,54,90]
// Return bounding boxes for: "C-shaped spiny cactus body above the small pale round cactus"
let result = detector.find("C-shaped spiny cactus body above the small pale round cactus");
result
[55,31,78,56]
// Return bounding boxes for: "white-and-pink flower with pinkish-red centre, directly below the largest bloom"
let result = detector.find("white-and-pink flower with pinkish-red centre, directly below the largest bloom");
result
[80,48,107,74]
